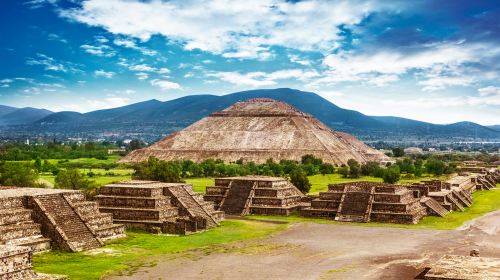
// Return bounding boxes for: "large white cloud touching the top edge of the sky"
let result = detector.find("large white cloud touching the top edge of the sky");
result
[60,0,390,58]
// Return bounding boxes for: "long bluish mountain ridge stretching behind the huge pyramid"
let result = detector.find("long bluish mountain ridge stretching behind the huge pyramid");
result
[0,88,500,140]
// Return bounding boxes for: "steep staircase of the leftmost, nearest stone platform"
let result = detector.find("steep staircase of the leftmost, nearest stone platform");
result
[33,194,103,252]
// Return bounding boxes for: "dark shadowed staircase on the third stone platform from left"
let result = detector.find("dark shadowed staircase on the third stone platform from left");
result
[220,181,255,215]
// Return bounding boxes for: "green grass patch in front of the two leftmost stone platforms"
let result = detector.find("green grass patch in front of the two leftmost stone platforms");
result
[33,220,287,280]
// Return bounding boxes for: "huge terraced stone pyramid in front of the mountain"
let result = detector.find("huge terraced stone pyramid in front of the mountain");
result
[122,98,388,164]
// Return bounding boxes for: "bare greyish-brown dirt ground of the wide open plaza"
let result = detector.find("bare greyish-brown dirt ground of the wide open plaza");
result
[109,211,500,279]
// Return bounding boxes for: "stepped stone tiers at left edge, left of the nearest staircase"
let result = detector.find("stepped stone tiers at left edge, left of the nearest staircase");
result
[0,197,50,252]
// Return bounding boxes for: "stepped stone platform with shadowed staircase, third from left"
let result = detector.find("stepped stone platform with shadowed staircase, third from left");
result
[204,176,306,216]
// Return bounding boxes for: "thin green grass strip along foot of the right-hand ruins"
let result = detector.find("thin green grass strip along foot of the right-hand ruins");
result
[248,188,500,230]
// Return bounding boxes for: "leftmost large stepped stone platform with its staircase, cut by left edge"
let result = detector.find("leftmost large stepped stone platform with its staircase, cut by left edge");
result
[0,187,125,252]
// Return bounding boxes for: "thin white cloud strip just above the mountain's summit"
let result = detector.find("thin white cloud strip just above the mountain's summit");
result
[206,69,319,87]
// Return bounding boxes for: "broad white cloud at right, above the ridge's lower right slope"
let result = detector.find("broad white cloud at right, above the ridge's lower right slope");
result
[314,42,500,91]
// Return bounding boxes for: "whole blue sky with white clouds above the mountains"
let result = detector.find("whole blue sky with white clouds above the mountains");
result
[0,0,500,124]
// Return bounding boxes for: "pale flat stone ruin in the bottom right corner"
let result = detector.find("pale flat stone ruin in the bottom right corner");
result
[415,255,500,280]
